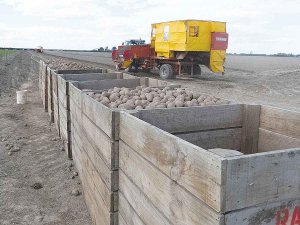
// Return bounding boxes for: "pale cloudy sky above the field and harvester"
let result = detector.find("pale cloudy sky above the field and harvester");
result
[0,0,300,54]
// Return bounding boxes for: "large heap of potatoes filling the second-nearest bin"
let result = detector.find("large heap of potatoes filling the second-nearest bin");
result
[87,86,229,110]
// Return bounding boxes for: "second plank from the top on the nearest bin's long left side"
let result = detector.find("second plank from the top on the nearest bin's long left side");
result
[120,140,223,225]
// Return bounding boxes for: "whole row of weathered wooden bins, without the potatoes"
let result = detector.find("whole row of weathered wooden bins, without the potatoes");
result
[40,62,300,225]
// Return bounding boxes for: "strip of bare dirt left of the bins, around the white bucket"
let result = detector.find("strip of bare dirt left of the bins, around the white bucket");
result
[0,52,92,225]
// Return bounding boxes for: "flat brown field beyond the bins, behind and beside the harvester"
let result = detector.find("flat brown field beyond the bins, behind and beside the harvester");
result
[47,52,300,111]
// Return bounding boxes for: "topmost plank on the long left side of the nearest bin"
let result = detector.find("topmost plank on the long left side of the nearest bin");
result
[120,112,225,212]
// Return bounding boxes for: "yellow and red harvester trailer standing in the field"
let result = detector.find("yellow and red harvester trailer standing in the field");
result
[113,20,228,79]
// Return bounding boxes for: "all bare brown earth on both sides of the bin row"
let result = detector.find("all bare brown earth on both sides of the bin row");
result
[0,52,300,225]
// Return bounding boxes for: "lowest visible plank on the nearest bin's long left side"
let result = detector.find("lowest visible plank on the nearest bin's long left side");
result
[119,193,148,225]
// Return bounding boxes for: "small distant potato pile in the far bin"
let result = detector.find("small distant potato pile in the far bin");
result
[48,59,98,70]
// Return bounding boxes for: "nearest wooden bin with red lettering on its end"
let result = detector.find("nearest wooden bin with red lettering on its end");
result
[119,104,300,225]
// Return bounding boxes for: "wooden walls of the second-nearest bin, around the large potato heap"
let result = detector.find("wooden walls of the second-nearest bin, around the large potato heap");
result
[69,78,178,225]
